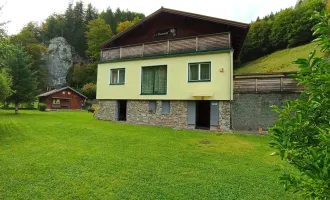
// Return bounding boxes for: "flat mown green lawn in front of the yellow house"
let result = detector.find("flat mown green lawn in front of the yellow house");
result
[0,110,296,200]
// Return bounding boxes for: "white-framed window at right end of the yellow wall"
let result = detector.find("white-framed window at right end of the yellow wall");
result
[188,62,211,82]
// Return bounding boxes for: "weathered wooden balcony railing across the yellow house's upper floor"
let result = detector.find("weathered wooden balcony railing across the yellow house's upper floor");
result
[101,33,231,61]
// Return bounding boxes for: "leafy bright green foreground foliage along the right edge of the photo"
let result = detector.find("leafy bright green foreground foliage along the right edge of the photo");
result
[269,11,330,199]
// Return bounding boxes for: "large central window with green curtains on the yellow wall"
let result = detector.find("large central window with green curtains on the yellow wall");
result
[141,65,167,95]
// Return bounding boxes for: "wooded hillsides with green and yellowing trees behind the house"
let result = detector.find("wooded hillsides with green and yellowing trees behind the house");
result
[0,0,329,108]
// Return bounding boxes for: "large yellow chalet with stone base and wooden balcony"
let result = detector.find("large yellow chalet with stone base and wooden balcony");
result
[97,8,249,131]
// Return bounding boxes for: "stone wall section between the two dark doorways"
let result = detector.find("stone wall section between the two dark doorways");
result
[127,100,187,129]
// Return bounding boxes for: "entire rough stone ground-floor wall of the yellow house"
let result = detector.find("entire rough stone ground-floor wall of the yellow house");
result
[97,100,230,132]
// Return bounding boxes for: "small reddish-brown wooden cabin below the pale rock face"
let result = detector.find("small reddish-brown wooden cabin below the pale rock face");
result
[38,87,87,110]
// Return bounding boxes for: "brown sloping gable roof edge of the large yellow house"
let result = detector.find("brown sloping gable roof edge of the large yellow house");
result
[100,7,250,49]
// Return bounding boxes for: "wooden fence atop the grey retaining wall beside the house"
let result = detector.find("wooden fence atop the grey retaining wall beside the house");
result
[234,72,304,93]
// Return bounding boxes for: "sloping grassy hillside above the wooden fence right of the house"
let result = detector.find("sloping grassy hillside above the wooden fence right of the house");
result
[234,43,323,74]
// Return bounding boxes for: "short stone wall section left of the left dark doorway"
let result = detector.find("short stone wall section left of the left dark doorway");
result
[97,100,117,121]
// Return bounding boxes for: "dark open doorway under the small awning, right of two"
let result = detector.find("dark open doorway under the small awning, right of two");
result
[196,101,211,129]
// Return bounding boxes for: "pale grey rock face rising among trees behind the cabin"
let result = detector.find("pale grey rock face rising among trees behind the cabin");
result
[46,37,73,87]
